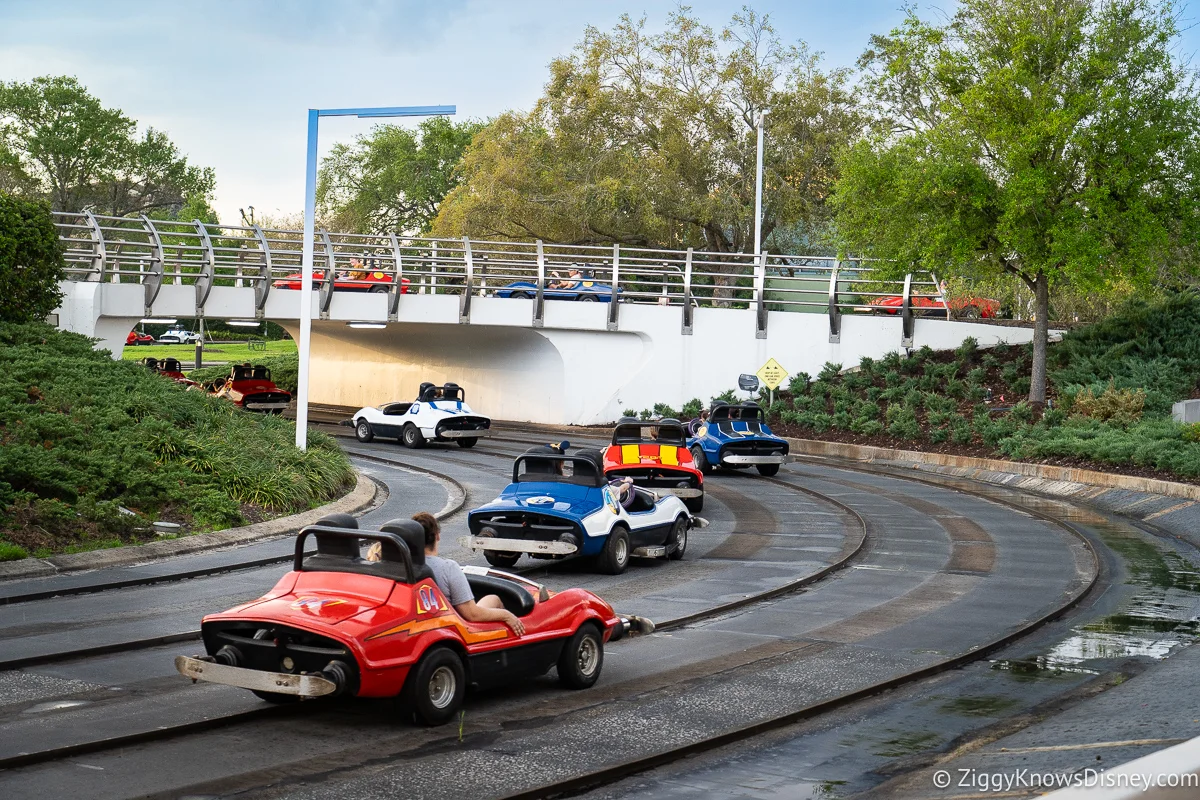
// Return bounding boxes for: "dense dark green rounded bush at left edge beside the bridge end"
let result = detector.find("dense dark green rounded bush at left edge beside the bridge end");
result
[0,193,66,323]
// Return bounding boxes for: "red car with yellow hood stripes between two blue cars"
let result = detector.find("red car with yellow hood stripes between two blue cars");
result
[604,417,704,513]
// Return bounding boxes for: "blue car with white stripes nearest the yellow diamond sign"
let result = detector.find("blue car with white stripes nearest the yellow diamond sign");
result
[688,403,787,476]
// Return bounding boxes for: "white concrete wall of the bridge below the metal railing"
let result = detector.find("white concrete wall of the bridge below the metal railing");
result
[60,282,1033,425]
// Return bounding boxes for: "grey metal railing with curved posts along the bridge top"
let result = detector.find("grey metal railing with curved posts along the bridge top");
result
[54,211,949,345]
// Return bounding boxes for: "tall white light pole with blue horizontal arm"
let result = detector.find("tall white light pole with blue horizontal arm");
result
[296,106,457,450]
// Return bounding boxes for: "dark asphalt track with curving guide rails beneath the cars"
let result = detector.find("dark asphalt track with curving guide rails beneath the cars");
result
[0,432,1098,798]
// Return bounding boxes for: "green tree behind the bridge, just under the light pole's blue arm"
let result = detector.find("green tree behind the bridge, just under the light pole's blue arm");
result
[317,116,484,234]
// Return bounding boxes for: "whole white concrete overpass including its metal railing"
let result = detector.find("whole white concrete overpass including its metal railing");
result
[56,212,1032,423]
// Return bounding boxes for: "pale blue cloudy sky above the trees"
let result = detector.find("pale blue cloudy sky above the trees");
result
[0,0,1200,223]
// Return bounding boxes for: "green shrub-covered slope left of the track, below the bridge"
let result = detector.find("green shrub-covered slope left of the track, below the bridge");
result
[0,324,353,559]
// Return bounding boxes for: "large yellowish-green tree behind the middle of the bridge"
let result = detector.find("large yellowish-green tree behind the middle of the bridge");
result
[434,8,859,252]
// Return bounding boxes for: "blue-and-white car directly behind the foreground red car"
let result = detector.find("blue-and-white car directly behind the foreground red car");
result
[462,441,708,575]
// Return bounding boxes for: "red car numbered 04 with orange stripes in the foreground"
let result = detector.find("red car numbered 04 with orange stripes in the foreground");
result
[175,515,628,724]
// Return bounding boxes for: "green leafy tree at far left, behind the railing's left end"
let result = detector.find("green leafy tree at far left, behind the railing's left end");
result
[0,76,215,216]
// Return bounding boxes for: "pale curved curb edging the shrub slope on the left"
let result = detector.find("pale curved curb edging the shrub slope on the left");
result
[0,470,388,581]
